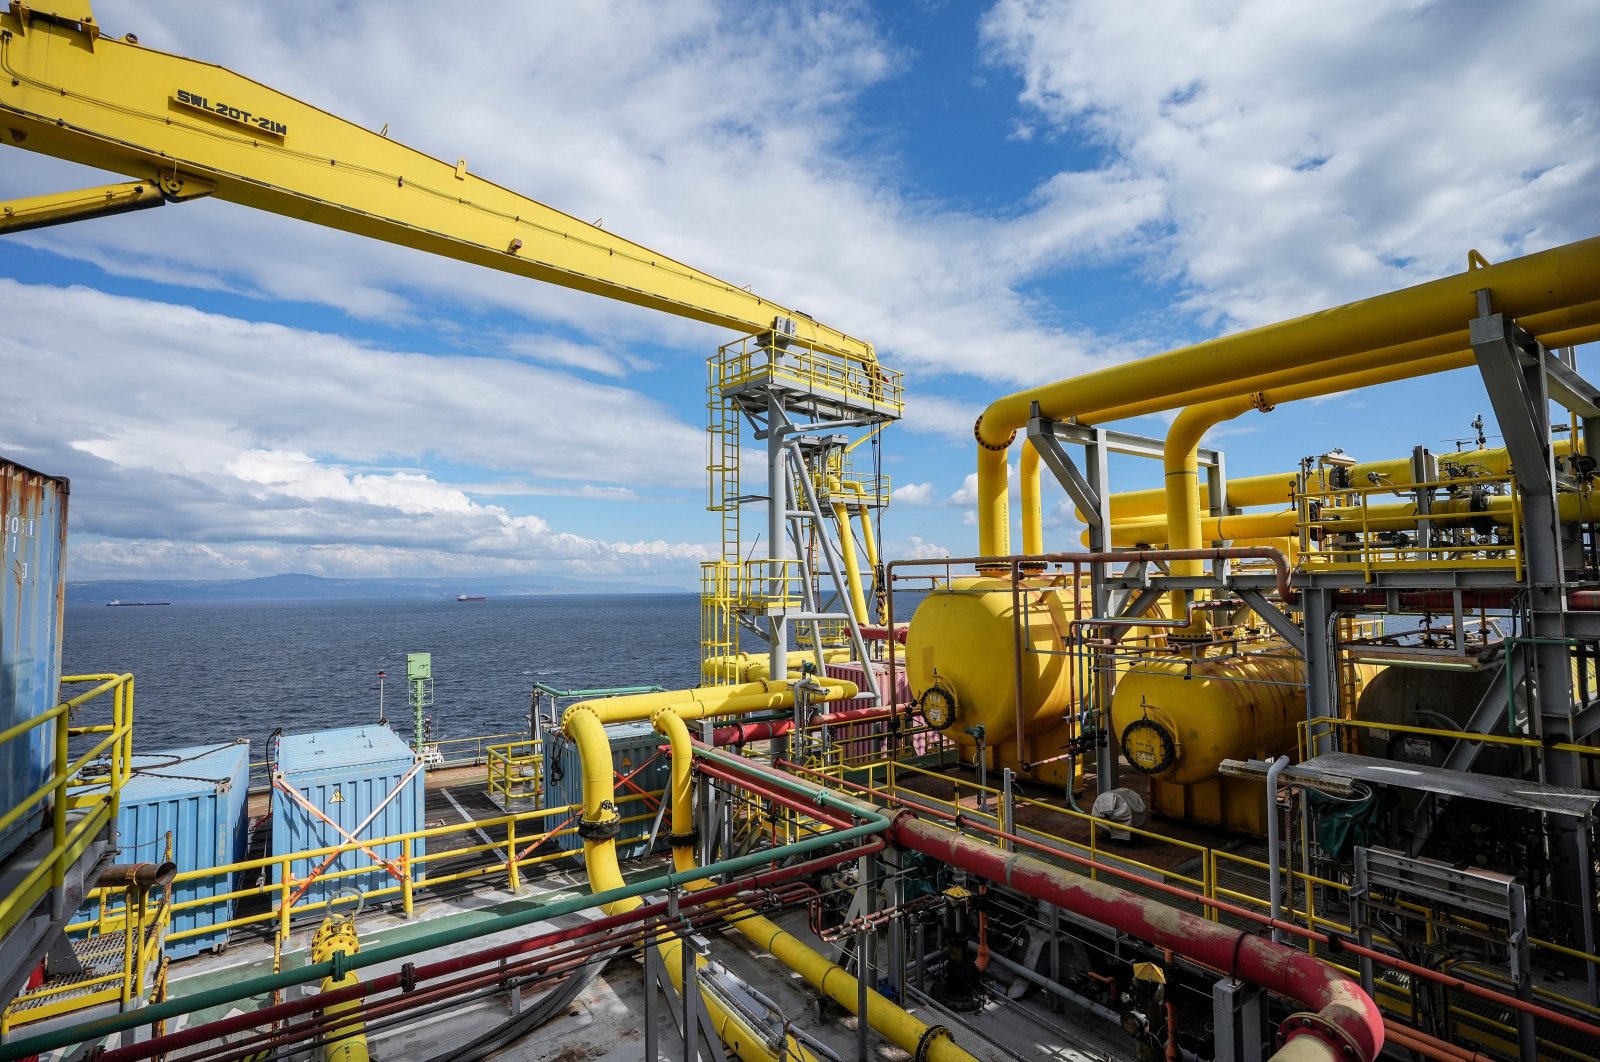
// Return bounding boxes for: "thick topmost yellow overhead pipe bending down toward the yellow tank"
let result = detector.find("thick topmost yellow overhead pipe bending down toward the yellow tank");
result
[973,237,1600,557]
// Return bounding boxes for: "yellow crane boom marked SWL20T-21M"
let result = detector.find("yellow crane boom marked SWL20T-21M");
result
[0,0,875,363]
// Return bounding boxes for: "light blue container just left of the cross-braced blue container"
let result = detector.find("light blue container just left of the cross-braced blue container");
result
[74,739,253,958]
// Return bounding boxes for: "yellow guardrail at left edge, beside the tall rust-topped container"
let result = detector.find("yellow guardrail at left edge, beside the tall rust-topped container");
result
[0,675,133,937]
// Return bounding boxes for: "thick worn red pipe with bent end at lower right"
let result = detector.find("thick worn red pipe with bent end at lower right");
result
[890,816,1384,1062]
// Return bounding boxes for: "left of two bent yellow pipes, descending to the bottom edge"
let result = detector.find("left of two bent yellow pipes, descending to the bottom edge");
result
[562,704,818,1062]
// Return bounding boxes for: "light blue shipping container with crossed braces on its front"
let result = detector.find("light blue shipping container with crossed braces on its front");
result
[272,725,424,905]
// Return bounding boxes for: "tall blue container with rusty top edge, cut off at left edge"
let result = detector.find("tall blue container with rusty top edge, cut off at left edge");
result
[0,459,67,859]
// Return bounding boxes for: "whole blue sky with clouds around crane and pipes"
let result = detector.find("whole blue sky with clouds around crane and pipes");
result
[0,0,1600,585]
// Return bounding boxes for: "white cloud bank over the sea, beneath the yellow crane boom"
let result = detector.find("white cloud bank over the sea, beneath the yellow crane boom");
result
[0,278,707,577]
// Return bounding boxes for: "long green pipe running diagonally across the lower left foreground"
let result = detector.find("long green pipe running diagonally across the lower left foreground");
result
[0,816,890,1060]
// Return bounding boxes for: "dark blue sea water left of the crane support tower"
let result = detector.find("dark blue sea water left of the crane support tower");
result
[62,593,699,758]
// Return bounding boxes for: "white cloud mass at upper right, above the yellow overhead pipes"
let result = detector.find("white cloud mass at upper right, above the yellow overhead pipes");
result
[982,0,1600,328]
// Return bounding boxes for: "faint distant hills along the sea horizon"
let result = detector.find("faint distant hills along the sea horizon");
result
[67,574,690,605]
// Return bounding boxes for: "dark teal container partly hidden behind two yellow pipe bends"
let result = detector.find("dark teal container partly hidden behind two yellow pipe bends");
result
[544,723,672,859]
